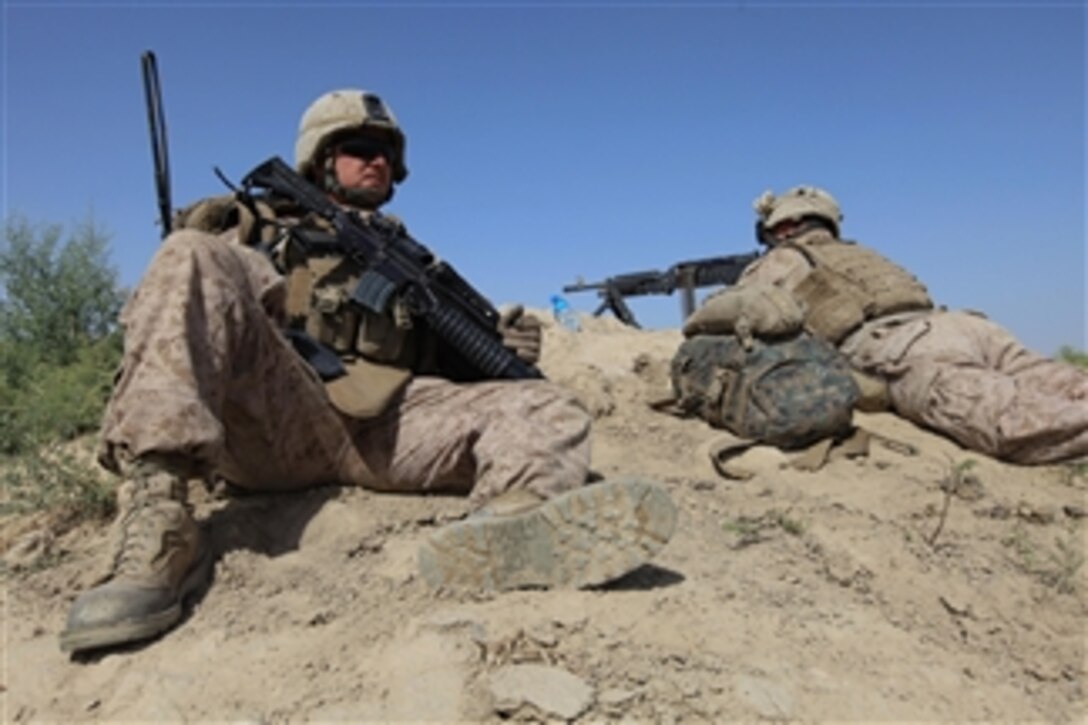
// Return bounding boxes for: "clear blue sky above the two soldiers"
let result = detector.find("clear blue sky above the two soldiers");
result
[0,0,1088,354]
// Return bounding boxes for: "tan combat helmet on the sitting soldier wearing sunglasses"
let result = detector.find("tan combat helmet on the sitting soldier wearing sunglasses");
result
[295,88,408,184]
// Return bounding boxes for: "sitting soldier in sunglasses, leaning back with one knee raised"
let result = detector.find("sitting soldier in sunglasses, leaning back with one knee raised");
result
[61,90,676,651]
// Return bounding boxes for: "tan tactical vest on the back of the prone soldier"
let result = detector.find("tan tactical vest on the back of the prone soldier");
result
[780,237,934,344]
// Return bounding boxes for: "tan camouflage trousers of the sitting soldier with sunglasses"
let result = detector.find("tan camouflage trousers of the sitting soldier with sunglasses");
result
[99,231,590,506]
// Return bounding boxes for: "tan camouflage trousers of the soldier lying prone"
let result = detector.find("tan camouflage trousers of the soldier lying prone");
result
[841,311,1088,464]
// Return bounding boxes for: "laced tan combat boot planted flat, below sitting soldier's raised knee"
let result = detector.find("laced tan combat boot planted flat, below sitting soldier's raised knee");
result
[61,460,211,652]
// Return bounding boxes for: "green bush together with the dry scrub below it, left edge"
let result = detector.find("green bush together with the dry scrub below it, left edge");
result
[0,217,126,519]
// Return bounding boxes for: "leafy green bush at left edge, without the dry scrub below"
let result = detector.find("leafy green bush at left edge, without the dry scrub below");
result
[0,217,125,455]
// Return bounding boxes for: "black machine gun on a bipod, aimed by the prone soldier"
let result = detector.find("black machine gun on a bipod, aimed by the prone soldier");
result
[562,251,759,328]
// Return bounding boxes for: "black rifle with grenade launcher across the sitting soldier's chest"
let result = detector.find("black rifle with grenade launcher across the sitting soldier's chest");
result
[242,157,543,380]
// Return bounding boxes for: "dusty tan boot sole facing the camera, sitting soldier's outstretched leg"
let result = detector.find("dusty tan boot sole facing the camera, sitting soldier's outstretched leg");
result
[419,478,677,590]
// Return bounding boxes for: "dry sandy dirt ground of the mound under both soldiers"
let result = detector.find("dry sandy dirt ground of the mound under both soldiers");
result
[0,318,1088,723]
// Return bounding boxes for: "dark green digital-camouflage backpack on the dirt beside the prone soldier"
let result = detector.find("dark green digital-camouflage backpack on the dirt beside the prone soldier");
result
[671,334,858,448]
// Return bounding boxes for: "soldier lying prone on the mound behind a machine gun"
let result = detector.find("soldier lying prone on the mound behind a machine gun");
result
[683,186,1088,464]
